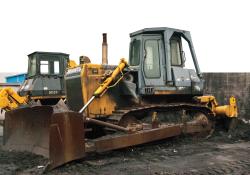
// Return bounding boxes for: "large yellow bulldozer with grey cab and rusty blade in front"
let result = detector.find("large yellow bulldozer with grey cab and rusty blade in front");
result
[0,27,237,169]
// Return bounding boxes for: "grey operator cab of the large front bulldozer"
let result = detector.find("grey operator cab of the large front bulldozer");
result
[129,28,203,95]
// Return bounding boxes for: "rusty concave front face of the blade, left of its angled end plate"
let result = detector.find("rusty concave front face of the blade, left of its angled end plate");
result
[3,106,53,157]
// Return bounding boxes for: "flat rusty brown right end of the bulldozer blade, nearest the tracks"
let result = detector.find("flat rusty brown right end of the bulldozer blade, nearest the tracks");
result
[46,112,85,170]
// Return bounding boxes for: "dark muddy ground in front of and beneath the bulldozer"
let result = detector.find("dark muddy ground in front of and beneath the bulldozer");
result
[0,121,250,175]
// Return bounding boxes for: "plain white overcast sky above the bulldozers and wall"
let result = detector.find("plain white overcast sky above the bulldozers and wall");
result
[0,0,250,72]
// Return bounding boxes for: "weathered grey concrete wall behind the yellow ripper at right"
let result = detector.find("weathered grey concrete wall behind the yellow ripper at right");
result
[203,73,250,120]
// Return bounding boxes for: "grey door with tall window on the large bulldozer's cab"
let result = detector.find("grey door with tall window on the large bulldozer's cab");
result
[142,35,165,87]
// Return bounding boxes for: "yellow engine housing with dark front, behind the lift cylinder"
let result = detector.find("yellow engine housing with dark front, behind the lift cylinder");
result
[65,64,119,118]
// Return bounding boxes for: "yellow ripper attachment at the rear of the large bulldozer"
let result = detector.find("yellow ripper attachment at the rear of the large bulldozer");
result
[197,96,238,118]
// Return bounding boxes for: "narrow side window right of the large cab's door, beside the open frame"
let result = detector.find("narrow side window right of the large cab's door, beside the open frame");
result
[170,37,182,66]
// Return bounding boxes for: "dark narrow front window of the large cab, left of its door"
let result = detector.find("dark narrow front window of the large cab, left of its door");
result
[129,40,141,66]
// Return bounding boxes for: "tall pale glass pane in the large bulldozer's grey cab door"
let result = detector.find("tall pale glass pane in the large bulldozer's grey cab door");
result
[144,40,160,78]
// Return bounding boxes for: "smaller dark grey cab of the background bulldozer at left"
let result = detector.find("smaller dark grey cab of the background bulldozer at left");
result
[19,52,69,104]
